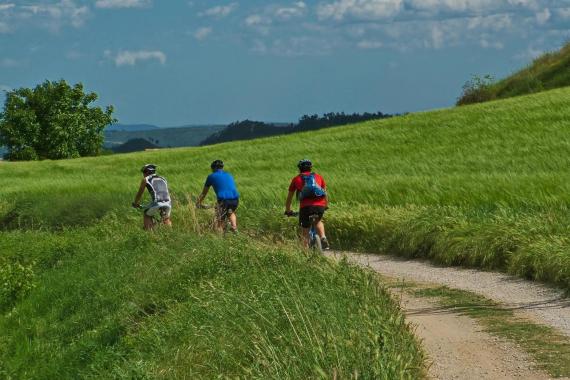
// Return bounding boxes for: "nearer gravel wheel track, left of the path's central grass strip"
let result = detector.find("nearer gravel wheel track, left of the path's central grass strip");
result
[402,294,550,380]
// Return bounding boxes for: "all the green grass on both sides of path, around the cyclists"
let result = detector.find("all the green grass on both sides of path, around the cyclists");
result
[0,84,570,378]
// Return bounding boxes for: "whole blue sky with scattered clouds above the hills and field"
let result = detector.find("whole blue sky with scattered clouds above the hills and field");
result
[0,0,570,126]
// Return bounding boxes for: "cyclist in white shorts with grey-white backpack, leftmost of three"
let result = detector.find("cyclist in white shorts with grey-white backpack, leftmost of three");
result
[133,164,172,230]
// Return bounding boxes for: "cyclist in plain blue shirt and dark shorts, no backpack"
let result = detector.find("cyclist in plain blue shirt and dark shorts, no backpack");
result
[196,160,239,232]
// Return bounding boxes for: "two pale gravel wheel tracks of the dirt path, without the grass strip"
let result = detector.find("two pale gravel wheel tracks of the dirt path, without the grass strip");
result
[329,253,570,380]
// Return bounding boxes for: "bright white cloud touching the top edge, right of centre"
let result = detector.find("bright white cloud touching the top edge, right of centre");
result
[317,0,404,21]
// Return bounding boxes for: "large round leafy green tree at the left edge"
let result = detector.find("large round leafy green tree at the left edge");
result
[0,79,116,160]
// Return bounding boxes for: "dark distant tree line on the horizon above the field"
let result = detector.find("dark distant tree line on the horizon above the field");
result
[200,112,393,146]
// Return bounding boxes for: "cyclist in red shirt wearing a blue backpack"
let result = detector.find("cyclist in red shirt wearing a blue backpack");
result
[285,159,330,249]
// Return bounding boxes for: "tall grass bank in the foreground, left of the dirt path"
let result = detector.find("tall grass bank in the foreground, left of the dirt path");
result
[0,215,423,379]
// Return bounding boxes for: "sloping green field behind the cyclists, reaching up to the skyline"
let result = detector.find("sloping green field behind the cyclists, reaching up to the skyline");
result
[0,89,570,288]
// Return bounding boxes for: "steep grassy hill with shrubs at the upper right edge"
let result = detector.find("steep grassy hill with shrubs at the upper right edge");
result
[457,42,570,105]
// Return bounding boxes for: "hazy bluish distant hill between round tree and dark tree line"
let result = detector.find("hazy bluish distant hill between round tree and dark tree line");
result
[105,125,225,150]
